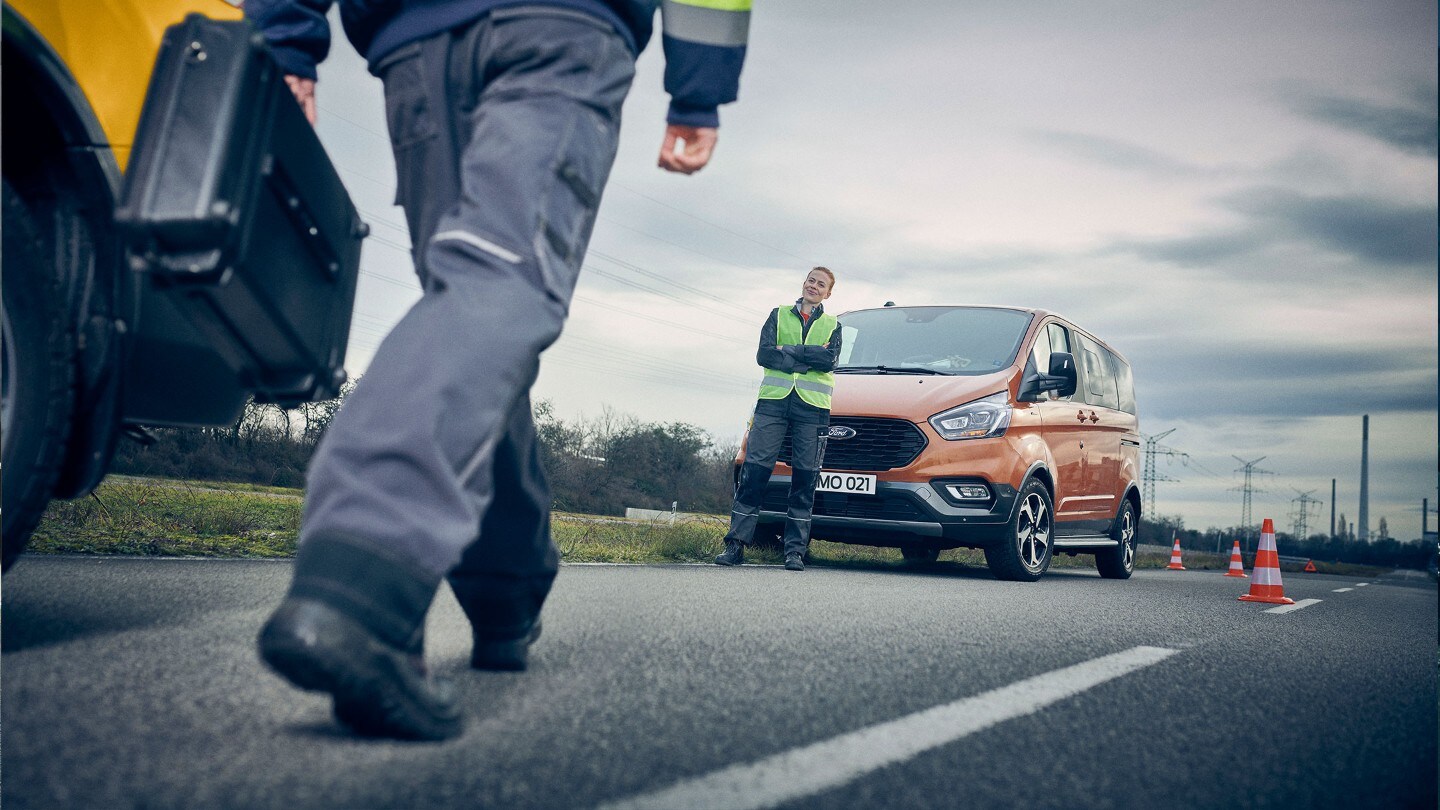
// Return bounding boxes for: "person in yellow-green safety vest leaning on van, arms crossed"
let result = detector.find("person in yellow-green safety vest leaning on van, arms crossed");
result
[716,267,841,571]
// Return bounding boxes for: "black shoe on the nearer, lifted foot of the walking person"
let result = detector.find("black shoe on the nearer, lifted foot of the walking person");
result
[259,597,464,739]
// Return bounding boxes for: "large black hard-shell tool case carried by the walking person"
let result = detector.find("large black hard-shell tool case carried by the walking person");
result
[115,14,367,424]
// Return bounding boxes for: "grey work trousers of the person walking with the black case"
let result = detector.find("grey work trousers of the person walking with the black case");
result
[301,7,635,637]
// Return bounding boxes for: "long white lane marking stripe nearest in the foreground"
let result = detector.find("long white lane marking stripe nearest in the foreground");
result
[599,647,1179,810]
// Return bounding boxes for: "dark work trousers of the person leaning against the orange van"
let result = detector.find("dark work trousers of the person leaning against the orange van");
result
[724,392,829,555]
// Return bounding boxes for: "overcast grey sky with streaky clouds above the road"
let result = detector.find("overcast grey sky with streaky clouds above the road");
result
[309,0,1437,539]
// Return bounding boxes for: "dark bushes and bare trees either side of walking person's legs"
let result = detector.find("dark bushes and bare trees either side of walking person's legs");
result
[111,383,737,515]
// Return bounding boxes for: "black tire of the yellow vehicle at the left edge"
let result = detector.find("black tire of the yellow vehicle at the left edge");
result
[0,182,75,569]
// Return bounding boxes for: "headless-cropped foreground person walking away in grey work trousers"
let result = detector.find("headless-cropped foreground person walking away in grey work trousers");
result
[245,0,750,739]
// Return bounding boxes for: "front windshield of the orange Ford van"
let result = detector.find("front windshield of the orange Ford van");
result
[835,307,1031,376]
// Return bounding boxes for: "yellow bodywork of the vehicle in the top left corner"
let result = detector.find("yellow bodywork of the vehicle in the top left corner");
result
[6,0,240,172]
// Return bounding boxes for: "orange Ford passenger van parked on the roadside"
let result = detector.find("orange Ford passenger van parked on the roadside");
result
[759,306,1140,581]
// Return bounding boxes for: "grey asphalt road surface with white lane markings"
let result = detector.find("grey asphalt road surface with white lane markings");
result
[0,556,1437,810]
